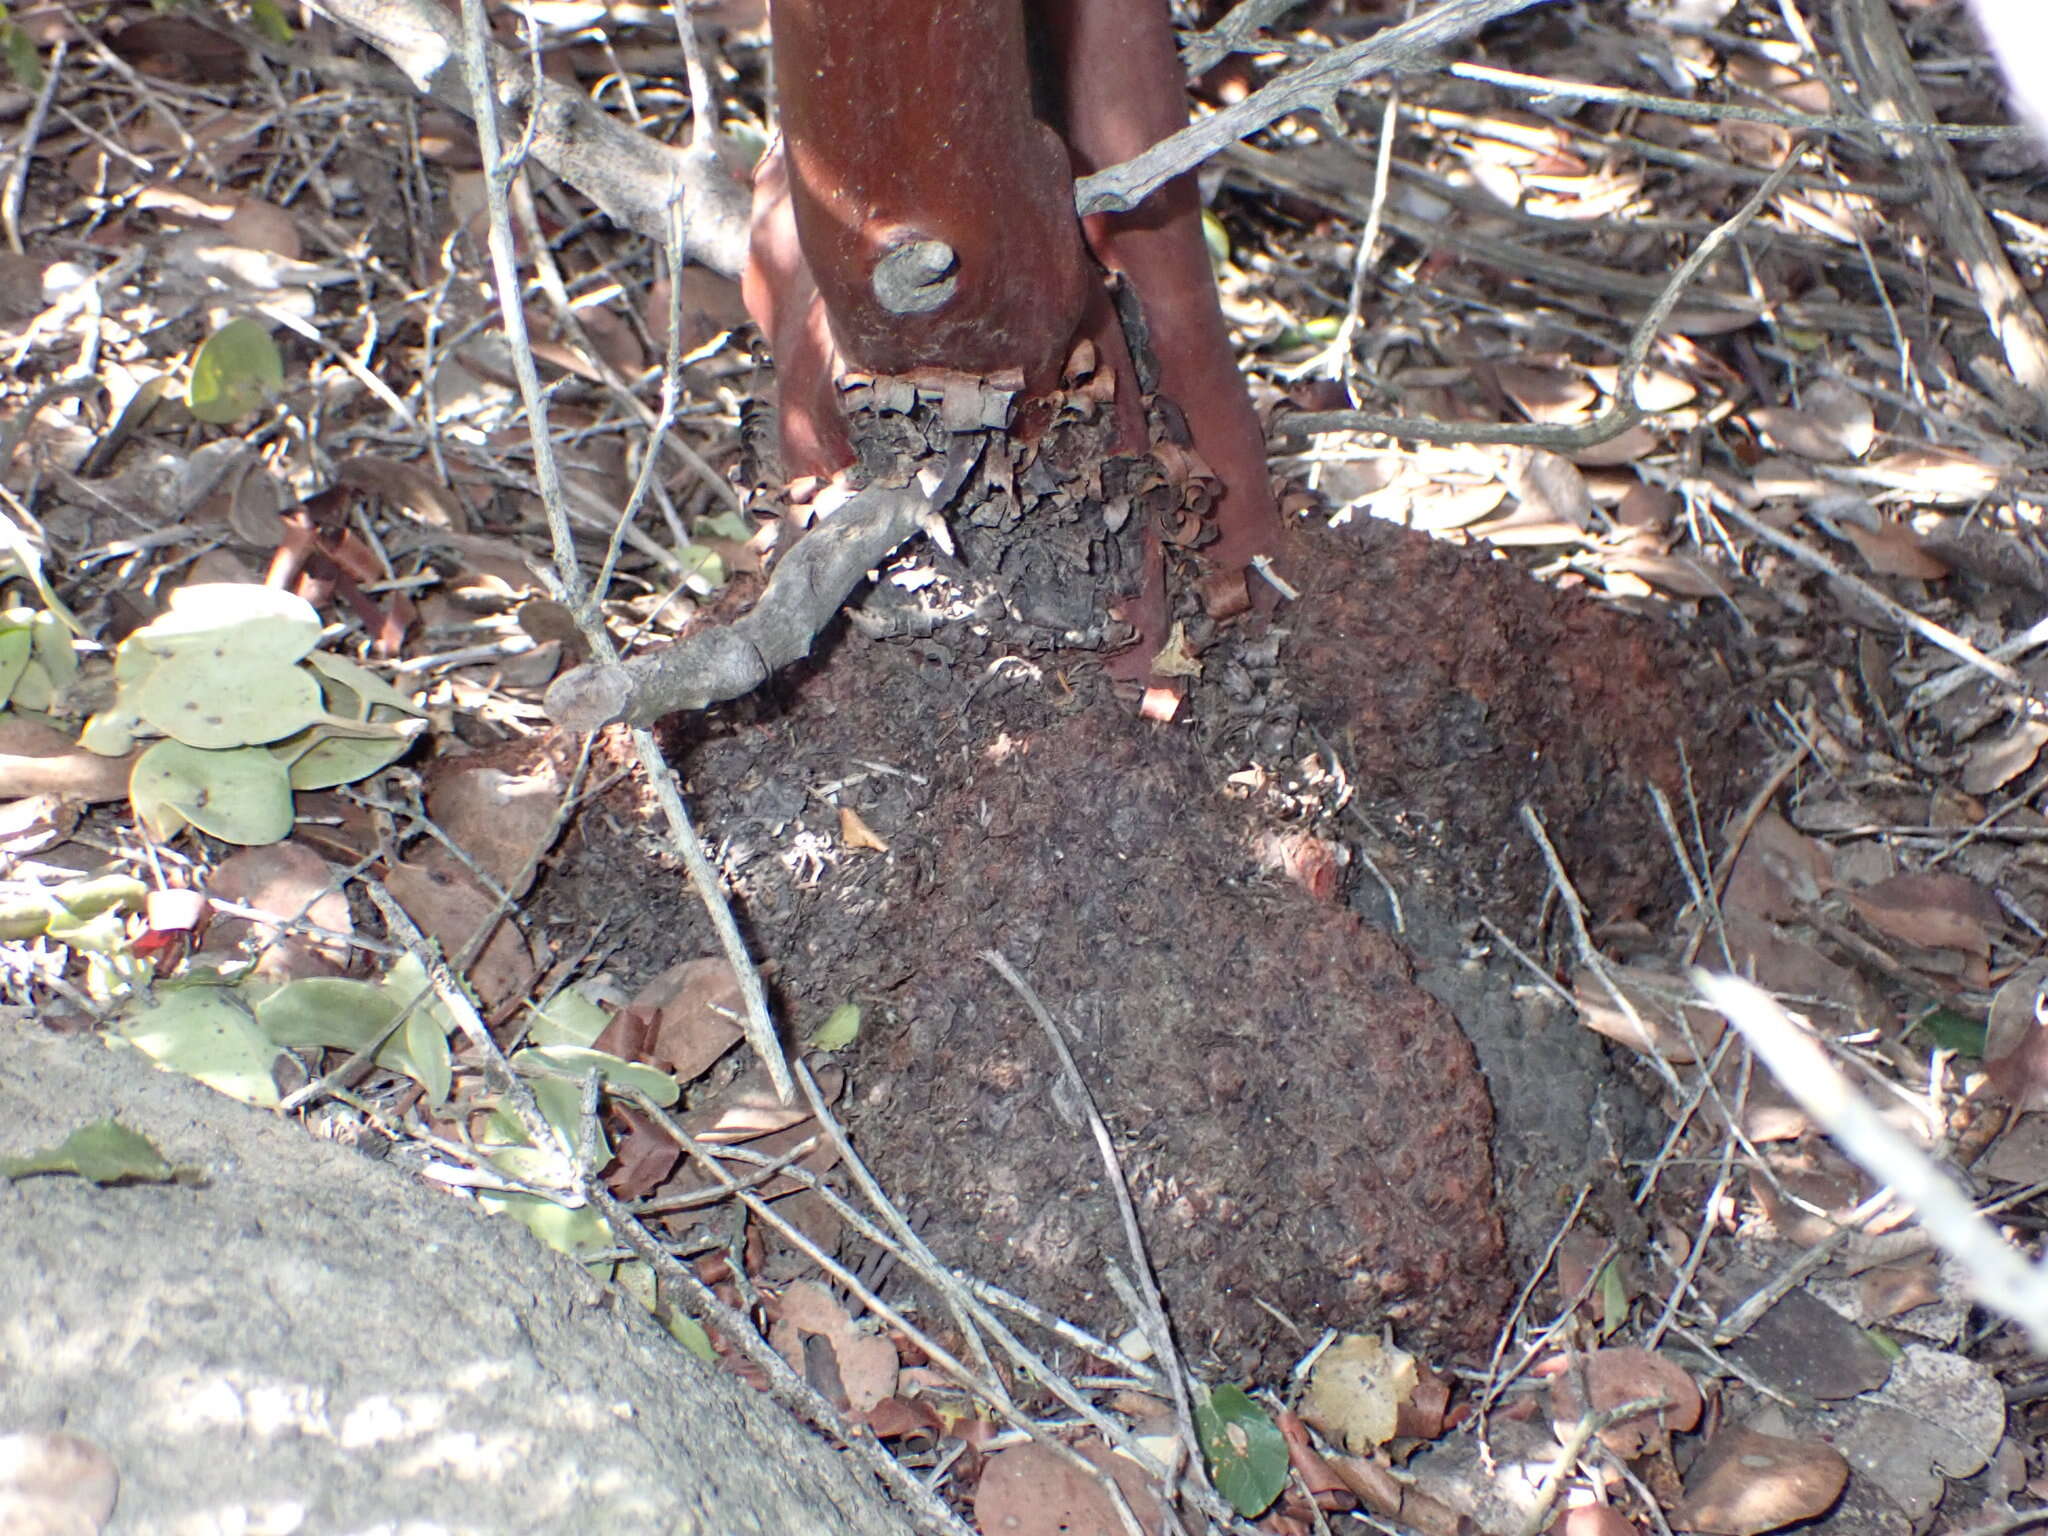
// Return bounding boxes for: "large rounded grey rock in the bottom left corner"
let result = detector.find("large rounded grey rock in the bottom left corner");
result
[0,1014,909,1536]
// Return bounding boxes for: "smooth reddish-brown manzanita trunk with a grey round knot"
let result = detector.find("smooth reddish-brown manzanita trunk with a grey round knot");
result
[745,0,1278,672]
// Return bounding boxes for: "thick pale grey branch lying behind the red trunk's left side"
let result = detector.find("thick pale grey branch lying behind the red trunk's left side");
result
[309,0,748,276]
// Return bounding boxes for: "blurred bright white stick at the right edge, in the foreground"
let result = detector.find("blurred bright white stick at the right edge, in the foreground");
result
[1692,969,2048,1350]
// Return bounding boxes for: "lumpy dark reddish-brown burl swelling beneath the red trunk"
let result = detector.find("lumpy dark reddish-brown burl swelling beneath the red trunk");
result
[545,514,1726,1372]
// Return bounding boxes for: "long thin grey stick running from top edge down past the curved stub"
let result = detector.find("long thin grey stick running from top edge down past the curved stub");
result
[450,0,797,1104]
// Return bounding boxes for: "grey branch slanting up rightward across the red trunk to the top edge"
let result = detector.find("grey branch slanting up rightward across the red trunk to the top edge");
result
[1073,0,1548,217]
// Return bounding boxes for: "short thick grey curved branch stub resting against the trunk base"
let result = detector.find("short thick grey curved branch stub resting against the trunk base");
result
[545,485,932,731]
